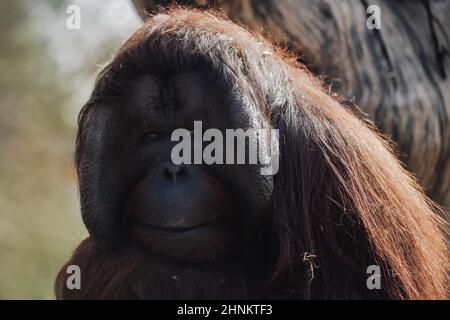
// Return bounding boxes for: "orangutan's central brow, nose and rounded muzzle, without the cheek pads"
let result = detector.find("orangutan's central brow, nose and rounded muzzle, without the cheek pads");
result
[126,72,236,263]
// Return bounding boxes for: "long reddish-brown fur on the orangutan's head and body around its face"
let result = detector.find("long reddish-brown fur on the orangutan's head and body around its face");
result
[56,9,449,299]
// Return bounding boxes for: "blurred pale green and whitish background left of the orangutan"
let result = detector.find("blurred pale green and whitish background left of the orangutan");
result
[0,0,141,299]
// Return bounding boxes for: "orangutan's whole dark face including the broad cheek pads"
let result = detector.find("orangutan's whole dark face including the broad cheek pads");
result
[80,70,273,265]
